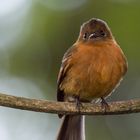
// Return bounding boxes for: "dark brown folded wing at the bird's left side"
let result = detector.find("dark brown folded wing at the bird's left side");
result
[57,46,77,101]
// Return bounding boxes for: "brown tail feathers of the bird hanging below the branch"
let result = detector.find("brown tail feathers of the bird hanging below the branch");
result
[57,115,85,140]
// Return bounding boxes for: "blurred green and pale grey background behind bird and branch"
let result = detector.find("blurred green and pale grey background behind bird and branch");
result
[0,0,140,140]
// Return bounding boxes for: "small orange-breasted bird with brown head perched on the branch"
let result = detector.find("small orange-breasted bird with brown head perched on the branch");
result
[57,18,128,140]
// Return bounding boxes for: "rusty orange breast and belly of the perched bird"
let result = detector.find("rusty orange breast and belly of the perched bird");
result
[63,42,125,100]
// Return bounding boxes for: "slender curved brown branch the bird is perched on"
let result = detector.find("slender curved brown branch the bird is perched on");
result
[0,93,140,115]
